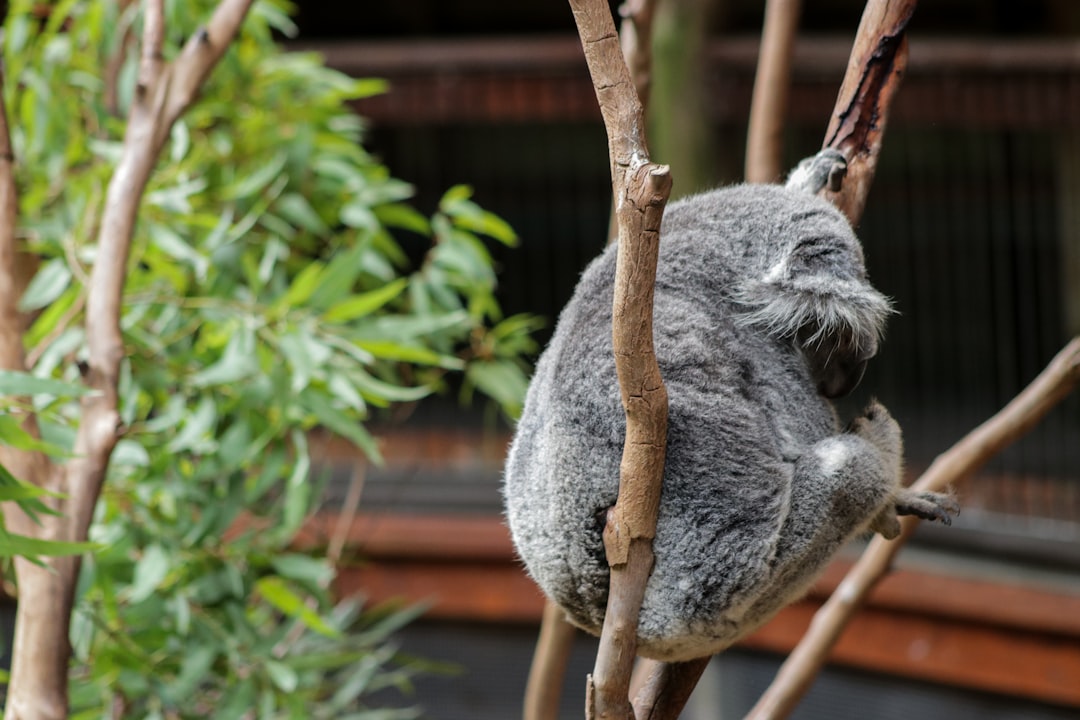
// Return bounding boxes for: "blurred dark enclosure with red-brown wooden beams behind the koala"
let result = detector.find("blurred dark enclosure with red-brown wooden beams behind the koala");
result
[294,0,1080,720]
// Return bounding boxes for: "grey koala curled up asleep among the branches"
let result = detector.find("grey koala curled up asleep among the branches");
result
[503,152,958,662]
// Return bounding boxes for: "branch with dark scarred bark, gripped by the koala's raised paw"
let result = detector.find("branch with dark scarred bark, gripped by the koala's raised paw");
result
[822,0,916,226]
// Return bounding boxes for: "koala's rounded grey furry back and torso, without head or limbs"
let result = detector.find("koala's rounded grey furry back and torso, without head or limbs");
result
[504,183,836,658]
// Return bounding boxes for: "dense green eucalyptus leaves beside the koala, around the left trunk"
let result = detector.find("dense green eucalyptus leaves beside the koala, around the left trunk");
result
[0,0,537,719]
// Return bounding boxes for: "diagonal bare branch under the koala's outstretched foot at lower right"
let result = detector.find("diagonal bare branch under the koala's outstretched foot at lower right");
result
[746,337,1080,720]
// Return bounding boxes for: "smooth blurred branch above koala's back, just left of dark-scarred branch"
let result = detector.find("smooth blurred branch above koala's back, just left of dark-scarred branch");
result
[745,0,802,182]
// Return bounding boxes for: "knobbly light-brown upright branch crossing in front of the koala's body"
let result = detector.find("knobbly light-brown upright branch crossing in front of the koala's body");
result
[570,0,671,718]
